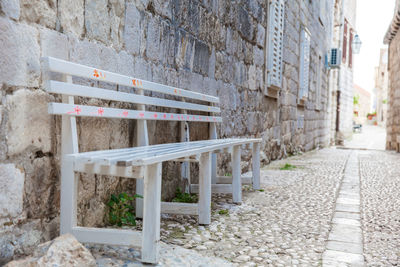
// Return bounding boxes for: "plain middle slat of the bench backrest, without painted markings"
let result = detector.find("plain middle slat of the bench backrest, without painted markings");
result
[46,81,221,112]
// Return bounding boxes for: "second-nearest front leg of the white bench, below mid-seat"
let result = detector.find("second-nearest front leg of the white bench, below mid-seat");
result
[199,152,211,224]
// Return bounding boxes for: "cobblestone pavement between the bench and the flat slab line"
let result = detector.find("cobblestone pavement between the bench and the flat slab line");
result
[91,148,350,266]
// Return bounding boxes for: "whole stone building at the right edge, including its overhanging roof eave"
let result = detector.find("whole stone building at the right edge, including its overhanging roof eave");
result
[384,0,400,151]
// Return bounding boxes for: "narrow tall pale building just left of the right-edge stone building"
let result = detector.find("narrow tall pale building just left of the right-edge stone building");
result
[375,48,389,126]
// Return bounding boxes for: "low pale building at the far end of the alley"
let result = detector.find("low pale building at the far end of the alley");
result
[354,84,371,124]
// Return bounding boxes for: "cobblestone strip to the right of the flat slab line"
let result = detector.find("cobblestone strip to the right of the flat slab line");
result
[359,151,400,266]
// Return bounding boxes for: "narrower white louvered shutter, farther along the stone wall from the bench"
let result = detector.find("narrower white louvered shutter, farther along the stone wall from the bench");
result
[299,28,311,100]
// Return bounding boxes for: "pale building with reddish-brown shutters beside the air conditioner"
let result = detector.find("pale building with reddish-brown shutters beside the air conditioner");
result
[330,0,357,144]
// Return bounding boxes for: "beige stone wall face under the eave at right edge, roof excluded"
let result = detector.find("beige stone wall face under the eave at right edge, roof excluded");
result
[386,32,400,150]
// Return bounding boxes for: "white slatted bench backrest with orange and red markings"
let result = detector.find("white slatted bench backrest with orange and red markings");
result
[42,57,222,153]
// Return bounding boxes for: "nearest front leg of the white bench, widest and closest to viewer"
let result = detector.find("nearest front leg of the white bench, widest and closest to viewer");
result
[142,163,162,263]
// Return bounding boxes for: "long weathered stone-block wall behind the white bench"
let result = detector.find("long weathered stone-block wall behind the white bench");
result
[0,0,330,264]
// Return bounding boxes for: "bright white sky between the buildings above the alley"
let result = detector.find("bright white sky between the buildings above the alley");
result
[354,0,396,92]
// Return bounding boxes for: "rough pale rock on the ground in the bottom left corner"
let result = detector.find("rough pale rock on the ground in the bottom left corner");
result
[6,234,96,267]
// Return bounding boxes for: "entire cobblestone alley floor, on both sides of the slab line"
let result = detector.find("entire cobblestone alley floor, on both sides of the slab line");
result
[90,148,400,266]
